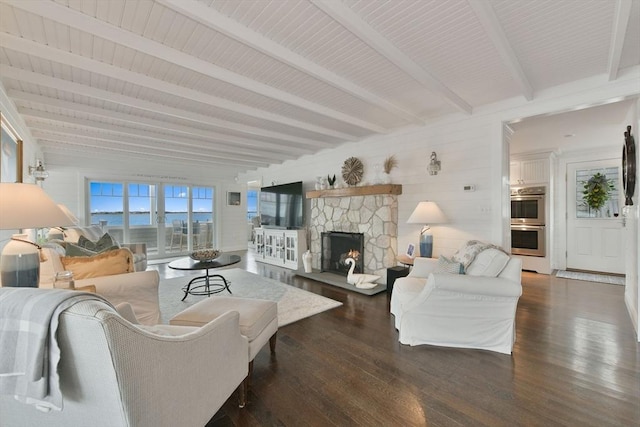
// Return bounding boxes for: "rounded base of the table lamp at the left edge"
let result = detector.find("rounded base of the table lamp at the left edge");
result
[0,234,40,288]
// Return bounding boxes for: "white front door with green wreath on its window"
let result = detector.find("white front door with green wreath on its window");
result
[567,159,625,274]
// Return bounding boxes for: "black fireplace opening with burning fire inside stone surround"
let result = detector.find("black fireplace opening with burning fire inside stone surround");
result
[320,231,364,276]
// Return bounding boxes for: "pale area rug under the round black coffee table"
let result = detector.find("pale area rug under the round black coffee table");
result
[160,268,342,327]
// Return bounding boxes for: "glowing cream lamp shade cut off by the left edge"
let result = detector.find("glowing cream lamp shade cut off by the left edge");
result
[0,183,73,230]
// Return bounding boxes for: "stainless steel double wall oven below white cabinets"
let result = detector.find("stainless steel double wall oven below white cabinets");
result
[511,186,547,257]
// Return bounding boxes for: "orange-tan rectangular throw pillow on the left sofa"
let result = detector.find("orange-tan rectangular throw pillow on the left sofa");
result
[61,248,135,279]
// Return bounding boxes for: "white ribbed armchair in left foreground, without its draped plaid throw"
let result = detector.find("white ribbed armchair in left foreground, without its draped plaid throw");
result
[0,300,248,427]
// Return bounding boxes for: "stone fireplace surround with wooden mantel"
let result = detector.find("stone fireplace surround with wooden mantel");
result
[307,185,402,282]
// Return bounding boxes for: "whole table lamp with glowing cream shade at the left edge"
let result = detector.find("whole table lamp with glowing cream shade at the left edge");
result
[0,183,72,288]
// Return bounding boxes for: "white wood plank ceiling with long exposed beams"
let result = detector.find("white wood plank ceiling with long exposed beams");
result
[0,0,640,178]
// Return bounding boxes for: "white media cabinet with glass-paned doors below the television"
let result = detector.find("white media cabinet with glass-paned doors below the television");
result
[254,228,307,270]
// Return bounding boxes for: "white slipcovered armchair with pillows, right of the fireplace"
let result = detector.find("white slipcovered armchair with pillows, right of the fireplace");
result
[391,241,522,354]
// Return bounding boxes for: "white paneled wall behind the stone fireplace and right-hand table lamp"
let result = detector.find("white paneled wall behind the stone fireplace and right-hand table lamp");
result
[241,113,501,256]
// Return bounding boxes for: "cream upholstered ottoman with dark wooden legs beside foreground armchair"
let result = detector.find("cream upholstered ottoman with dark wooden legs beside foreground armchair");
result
[169,296,278,407]
